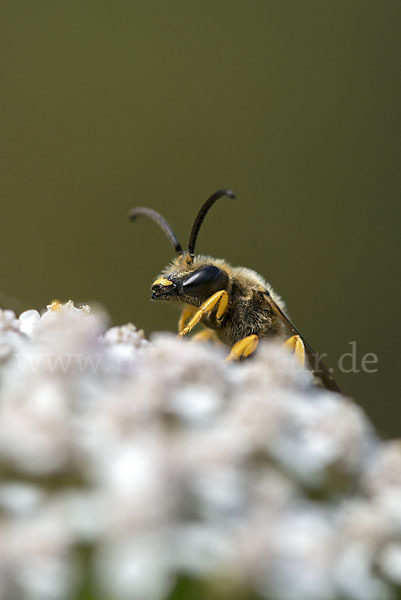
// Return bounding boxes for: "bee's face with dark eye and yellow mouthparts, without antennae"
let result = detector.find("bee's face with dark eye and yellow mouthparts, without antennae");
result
[152,264,229,306]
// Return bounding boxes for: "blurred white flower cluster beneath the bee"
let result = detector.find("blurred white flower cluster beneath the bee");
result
[0,302,401,600]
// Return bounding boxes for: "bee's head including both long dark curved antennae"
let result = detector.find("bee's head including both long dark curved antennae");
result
[130,189,235,305]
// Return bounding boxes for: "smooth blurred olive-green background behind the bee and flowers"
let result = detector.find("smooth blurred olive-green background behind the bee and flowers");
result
[0,0,401,436]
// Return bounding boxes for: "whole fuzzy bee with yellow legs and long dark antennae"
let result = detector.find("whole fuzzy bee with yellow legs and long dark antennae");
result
[129,189,340,392]
